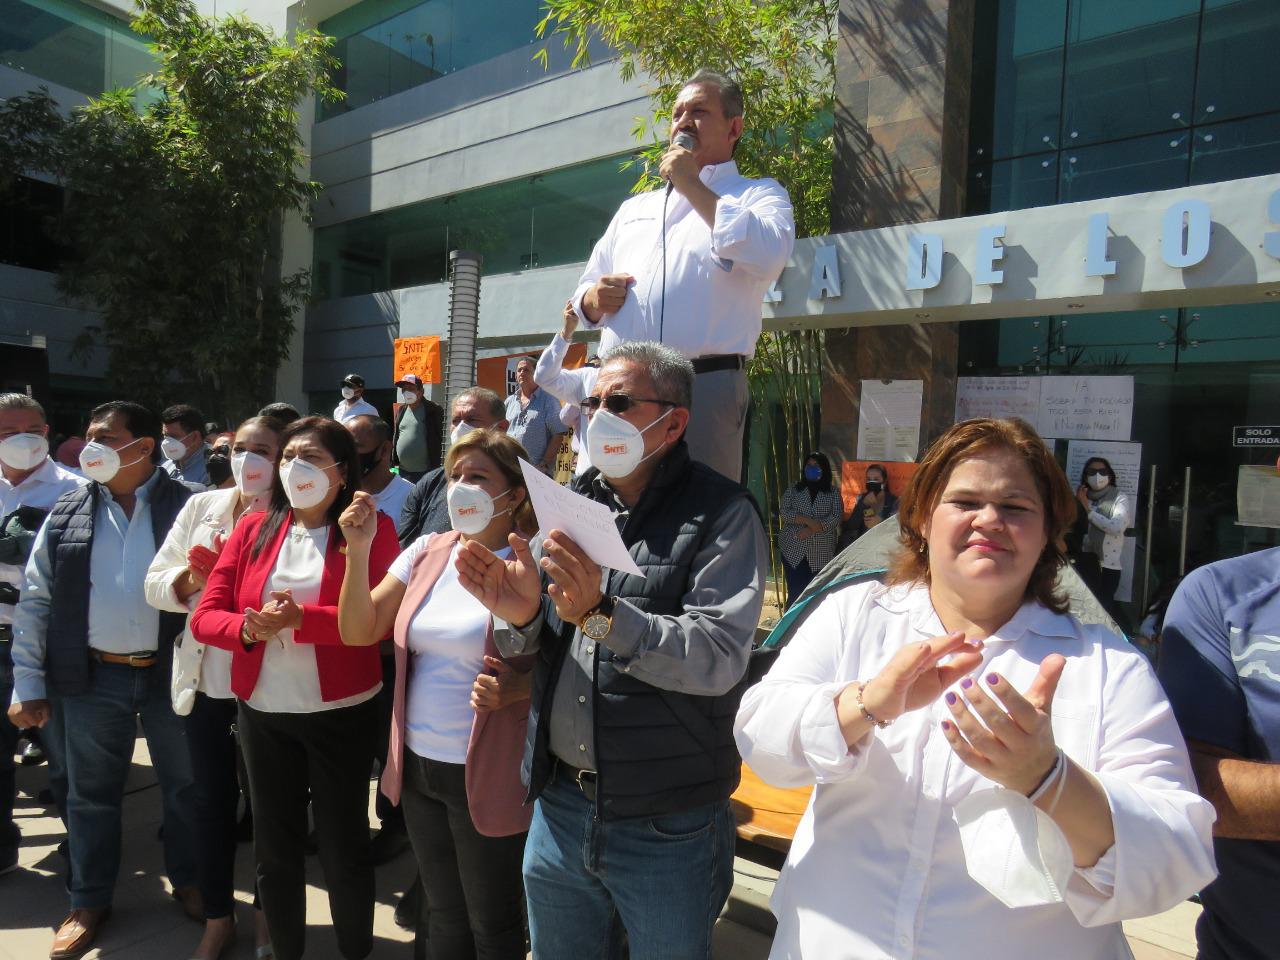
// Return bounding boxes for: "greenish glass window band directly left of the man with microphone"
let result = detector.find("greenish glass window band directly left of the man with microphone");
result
[315,156,635,300]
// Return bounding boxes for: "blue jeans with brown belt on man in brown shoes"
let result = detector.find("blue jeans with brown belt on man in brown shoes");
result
[60,657,196,909]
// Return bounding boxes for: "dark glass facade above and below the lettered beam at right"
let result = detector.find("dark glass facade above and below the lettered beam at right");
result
[957,0,1280,626]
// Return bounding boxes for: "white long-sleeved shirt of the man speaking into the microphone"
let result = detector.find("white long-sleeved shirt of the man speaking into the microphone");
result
[573,160,796,358]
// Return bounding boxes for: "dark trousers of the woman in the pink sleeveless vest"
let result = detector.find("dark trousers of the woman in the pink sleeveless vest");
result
[401,749,526,960]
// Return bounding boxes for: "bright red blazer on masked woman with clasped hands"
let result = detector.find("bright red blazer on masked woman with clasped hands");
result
[191,513,399,701]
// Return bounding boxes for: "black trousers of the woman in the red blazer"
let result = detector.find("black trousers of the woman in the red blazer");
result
[237,699,378,960]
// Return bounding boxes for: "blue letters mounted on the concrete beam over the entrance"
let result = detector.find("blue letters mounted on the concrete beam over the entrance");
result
[764,180,1280,303]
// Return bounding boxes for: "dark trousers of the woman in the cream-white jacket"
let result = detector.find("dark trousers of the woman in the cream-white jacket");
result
[187,692,248,920]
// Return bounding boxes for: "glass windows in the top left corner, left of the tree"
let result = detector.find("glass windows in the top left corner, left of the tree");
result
[0,0,155,96]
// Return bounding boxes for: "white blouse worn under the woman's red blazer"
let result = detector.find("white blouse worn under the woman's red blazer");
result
[247,524,383,713]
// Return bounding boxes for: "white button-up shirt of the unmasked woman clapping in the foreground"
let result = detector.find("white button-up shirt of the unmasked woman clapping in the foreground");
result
[735,582,1215,960]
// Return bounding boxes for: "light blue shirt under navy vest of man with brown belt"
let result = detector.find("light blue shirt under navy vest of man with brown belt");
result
[13,468,164,701]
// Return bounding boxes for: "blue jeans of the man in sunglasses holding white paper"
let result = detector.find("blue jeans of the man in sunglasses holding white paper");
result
[525,776,736,960]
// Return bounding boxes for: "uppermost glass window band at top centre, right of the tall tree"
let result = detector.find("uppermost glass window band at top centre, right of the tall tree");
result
[317,0,541,120]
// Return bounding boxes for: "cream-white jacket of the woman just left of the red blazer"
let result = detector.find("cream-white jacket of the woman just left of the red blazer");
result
[145,486,269,701]
